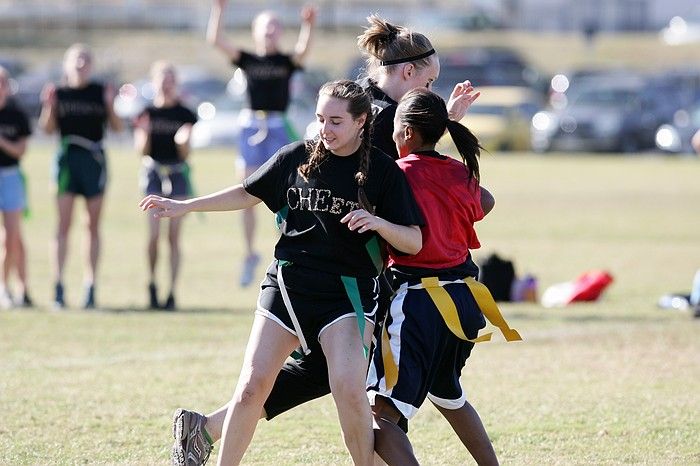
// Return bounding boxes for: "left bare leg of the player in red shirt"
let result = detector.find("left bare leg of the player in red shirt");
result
[372,396,418,466]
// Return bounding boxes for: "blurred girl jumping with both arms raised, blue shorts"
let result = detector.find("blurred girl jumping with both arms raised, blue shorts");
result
[207,0,316,286]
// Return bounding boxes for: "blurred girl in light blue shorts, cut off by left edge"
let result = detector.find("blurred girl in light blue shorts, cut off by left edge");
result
[0,66,33,308]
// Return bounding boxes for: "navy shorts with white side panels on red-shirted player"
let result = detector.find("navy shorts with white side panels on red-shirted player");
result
[367,281,486,419]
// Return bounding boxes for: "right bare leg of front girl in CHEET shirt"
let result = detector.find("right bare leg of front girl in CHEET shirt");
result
[320,318,374,465]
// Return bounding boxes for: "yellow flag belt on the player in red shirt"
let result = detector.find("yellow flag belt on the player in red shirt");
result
[398,277,522,343]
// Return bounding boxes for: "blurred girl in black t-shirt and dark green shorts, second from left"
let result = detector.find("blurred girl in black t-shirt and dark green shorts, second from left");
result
[39,44,122,309]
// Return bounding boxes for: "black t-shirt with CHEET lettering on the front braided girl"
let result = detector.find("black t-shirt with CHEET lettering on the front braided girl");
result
[243,142,424,278]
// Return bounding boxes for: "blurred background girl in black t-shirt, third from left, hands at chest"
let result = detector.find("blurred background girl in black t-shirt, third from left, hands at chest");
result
[134,61,197,310]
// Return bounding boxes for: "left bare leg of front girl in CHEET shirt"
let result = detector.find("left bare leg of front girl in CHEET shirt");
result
[218,315,299,466]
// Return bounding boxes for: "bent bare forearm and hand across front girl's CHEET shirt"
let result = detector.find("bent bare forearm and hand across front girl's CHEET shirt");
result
[340,209,423,254]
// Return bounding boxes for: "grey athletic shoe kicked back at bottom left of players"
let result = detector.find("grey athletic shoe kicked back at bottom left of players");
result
[170,409,211,466]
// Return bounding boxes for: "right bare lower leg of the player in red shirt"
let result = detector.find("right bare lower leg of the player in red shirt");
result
[433,402,498,466]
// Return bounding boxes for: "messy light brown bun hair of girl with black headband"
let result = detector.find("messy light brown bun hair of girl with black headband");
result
[357,15,433,79]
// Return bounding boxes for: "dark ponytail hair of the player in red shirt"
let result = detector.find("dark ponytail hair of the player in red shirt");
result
[396,88,483,182]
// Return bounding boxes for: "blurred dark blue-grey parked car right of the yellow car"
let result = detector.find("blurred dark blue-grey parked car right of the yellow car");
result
[531,79,671,152]
